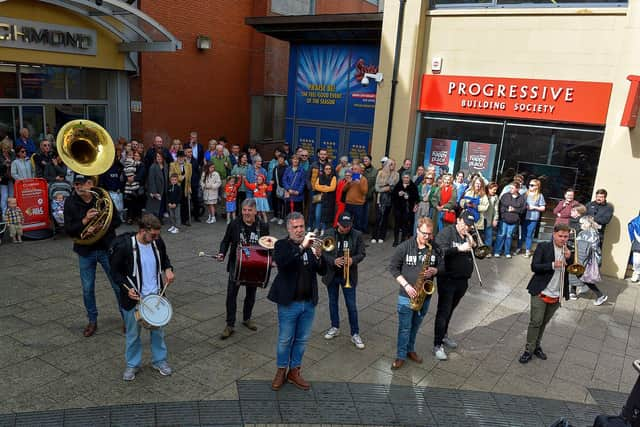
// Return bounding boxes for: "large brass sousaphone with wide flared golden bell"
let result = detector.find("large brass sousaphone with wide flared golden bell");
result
[56,120,116,245]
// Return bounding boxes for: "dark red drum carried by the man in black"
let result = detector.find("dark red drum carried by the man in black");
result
[233,246,271,288]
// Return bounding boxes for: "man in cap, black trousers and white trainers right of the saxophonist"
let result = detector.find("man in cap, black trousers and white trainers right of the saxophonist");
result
[433,209,475,360]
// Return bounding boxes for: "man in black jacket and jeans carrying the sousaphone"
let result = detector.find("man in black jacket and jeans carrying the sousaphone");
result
[64,175,124,337]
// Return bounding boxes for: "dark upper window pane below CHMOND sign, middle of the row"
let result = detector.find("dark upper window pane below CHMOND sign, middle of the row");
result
[20,65,66,99]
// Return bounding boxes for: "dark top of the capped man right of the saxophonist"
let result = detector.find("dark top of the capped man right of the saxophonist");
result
[436,224,473,280]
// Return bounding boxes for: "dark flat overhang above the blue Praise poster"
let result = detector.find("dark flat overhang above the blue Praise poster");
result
[244,13,382,42]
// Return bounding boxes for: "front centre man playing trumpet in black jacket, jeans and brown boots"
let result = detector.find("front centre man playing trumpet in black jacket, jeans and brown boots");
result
[266,212,327,390]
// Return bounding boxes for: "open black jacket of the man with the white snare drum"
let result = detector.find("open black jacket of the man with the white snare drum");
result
[109,233,173,311]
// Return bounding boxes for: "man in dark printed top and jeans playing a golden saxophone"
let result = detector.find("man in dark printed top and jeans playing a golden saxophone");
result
[389,217,444,369]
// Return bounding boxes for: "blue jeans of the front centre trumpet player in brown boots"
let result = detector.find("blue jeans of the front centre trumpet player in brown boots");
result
[276,301,316,368]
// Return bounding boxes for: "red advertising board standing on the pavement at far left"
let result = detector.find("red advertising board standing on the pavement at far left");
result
[14,178,51,232]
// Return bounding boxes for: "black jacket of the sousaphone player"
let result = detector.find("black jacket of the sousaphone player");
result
[64,192,122,256]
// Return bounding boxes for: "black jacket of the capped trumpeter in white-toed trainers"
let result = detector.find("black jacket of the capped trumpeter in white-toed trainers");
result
[322,228,366,287]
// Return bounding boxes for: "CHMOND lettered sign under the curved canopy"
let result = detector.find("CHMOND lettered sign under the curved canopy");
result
[0,16,97,55]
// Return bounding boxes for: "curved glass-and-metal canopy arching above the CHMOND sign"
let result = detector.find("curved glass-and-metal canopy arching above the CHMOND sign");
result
[40,0,182,52]
